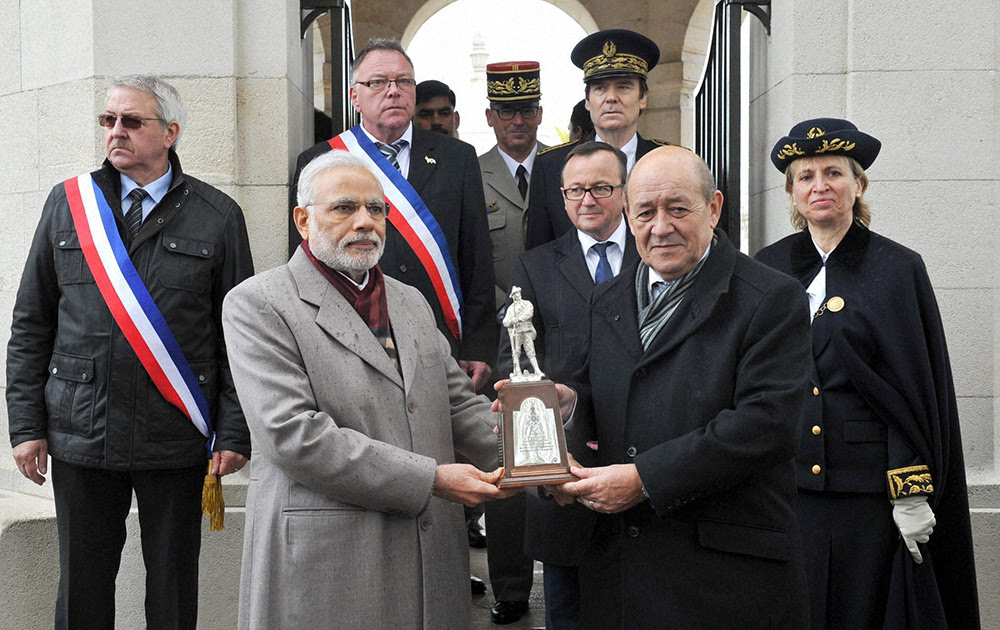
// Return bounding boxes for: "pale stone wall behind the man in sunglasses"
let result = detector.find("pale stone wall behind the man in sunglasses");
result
[0,0,312,628]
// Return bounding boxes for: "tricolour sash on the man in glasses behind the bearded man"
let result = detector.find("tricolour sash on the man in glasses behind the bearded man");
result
[329,125,462,341]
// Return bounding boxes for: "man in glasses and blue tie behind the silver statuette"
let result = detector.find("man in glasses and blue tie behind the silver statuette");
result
[497,142,639,630]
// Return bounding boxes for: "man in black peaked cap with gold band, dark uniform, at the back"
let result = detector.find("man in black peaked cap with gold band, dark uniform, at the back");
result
[526,29,669,249]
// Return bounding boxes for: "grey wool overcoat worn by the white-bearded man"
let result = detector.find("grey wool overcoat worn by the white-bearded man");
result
[223,251,497,629]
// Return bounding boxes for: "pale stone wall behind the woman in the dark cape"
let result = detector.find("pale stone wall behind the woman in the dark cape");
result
[750,0,1000,621]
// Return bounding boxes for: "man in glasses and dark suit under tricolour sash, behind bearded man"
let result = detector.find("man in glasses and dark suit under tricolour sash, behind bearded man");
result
[295,39,497,390]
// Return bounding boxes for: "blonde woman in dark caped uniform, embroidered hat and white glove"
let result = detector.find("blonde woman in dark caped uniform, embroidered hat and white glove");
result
[757,118,979,630]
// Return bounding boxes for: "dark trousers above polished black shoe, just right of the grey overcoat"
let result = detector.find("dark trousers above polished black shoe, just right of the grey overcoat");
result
[486,492,535,602]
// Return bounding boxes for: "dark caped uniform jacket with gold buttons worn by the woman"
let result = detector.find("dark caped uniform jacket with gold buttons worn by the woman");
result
[757,223,979,628]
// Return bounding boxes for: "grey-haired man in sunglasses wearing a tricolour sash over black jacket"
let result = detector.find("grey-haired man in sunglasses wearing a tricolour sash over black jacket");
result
[7,76,253,629]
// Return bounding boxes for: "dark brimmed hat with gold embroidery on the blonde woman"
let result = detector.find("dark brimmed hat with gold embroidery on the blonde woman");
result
[771,118,882,173]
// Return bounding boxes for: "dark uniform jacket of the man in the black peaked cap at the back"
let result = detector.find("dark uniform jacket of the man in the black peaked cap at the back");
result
[525,134,670,249]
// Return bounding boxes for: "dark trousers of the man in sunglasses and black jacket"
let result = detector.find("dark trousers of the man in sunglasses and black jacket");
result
[52,459,205,630]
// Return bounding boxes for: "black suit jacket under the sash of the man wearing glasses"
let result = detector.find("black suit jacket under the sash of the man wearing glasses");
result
[292,127,497,364]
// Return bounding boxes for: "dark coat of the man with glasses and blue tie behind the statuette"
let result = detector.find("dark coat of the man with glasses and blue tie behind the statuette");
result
[497,227,639,566]
